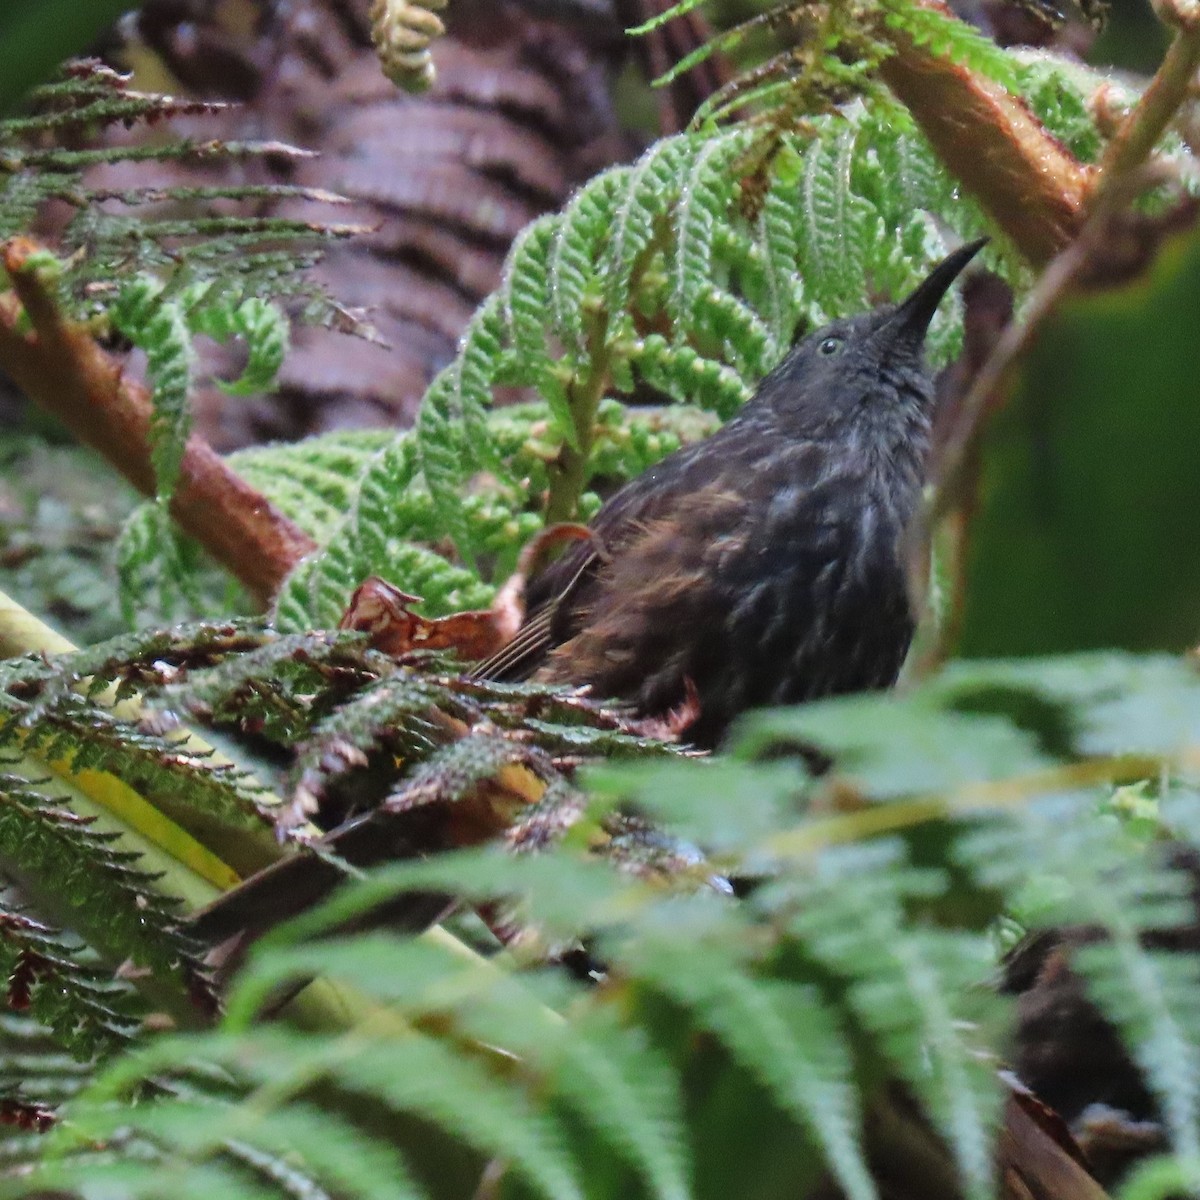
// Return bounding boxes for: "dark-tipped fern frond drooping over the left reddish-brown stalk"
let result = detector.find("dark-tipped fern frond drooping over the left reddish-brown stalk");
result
[0,62,356,520]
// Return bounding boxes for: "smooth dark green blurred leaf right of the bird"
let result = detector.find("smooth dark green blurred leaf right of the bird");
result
[960,225,1200,655]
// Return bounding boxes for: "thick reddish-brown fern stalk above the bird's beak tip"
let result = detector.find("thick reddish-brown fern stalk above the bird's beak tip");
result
[881,0,1097,266]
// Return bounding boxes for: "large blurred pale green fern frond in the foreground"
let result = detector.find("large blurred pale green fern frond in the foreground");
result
[16,652,1200,1200]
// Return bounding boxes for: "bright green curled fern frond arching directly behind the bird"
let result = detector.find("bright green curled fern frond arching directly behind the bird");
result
[112,32,1183,630]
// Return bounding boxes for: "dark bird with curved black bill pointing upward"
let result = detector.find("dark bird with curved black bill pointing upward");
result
[475,239,986,746]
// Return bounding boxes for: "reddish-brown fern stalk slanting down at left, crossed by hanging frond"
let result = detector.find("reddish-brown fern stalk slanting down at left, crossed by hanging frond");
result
[0,238,316,606]
